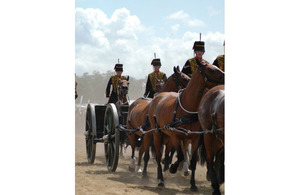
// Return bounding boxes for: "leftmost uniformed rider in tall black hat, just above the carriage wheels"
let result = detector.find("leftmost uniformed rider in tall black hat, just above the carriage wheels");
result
[106,64,126,103]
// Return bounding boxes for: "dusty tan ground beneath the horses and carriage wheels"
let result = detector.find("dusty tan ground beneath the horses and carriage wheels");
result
[75,131,224,195]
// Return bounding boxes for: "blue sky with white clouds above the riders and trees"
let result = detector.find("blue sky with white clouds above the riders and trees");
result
[75,0,225,79]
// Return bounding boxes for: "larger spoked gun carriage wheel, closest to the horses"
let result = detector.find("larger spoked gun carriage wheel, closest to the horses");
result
[104,104,120,172]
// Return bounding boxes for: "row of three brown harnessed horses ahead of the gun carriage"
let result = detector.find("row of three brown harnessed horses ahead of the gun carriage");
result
[119,62,225,194]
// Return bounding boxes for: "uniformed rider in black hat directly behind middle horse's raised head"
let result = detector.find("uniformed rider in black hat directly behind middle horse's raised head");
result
[182,41,209,77]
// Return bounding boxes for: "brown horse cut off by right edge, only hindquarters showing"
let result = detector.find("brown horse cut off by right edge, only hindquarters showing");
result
[198,85,225,194]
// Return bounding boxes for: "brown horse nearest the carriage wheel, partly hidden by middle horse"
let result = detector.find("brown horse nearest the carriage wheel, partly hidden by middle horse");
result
[127,66,190,178]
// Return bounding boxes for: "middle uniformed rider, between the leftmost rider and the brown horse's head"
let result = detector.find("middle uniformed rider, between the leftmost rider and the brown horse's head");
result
[144,58,167,98]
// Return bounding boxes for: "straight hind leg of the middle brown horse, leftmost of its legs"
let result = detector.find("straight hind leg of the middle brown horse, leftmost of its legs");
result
[153,132,165,187]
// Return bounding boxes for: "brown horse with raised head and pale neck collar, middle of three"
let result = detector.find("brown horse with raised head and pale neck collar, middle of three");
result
[149,60,224,191]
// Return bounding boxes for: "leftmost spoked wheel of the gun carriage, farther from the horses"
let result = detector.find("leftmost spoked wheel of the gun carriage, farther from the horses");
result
[85,104,96,164]
